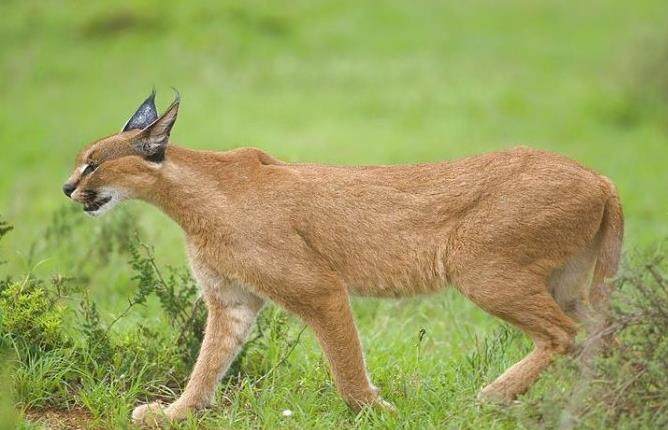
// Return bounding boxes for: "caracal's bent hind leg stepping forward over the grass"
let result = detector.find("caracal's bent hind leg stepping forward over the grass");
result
[460,271,577,403]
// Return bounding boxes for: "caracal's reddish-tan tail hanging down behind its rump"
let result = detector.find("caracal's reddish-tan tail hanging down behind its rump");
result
[590,176,624,313]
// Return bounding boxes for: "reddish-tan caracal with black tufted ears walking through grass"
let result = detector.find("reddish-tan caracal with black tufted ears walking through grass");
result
[63,93,623,423]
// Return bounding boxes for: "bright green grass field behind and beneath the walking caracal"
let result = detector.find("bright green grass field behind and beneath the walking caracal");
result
[0,0,668,428]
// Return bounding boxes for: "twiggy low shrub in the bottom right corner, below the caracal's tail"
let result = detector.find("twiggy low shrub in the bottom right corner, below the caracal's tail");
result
[516,250,668,429]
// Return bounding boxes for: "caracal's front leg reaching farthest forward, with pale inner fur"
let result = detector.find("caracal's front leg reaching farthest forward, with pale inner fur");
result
[132,282,263,424]
